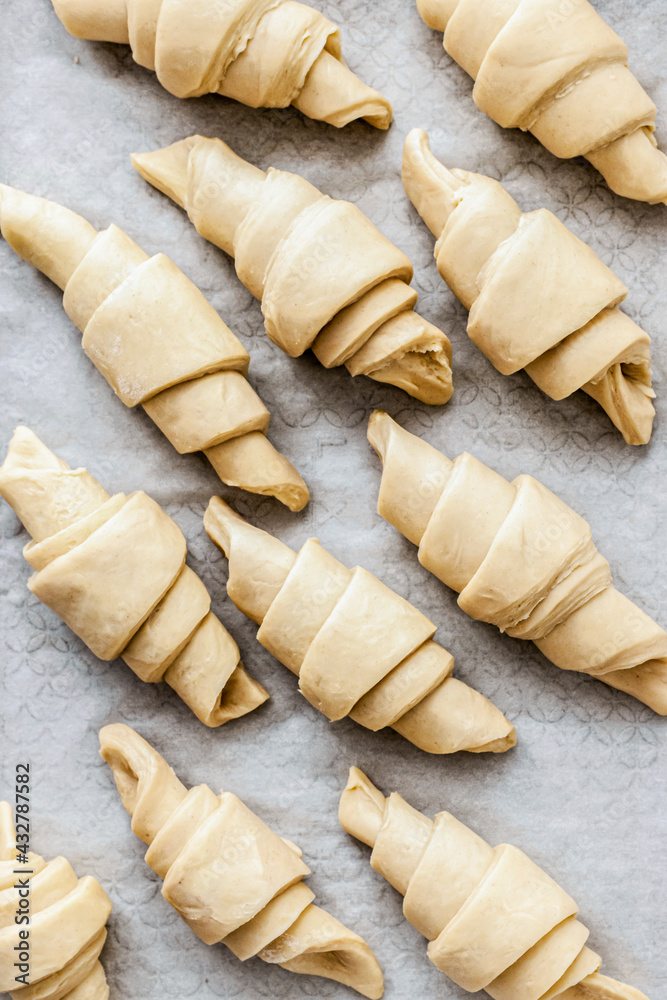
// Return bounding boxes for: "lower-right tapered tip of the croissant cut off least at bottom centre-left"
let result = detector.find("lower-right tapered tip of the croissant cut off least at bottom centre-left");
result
[272,903,384,1000]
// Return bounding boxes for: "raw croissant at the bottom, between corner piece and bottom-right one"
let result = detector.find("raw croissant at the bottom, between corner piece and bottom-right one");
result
[100,725,382,1000]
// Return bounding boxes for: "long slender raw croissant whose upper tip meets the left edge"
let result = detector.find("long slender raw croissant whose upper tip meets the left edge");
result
[0,184,308,510]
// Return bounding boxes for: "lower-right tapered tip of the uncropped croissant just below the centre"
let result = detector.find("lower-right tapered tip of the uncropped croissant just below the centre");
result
[392,677,516,754]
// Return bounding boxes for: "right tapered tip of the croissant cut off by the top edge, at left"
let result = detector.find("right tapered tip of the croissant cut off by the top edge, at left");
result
[292,49,393,130]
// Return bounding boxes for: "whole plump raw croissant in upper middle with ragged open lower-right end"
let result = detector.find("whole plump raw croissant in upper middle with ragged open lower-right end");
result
[132,135,452,404]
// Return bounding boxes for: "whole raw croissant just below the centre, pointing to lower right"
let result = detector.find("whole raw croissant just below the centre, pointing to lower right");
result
[204,497,516,753]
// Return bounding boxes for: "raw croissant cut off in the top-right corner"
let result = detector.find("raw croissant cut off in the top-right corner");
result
[417,0,667,204]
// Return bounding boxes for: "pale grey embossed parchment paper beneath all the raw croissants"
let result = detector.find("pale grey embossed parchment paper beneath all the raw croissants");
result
[0,0,667,1000]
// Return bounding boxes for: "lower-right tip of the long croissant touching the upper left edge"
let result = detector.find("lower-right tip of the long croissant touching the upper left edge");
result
[204,431,310,511]
